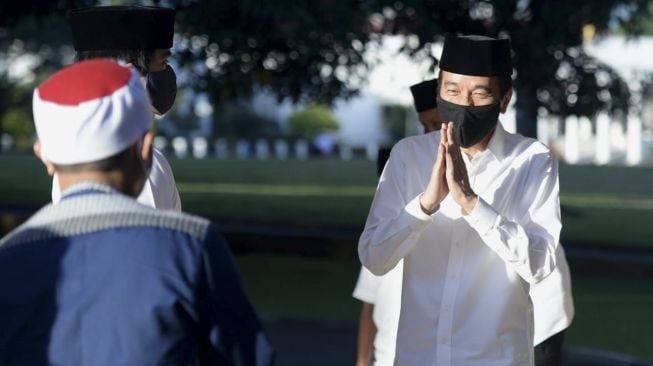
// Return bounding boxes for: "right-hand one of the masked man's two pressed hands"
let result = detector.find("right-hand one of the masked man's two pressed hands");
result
[442,123,478,215]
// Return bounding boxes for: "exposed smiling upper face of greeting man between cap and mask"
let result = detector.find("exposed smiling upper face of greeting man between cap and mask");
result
[440,71,510,112]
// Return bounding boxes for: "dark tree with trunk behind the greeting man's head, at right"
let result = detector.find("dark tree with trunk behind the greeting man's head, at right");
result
[364,0,650,136]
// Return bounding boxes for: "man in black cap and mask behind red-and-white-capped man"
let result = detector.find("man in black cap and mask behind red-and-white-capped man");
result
[52,6,181,212]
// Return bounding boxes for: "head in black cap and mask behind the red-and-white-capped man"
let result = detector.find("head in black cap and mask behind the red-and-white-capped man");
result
[71,6,177,114]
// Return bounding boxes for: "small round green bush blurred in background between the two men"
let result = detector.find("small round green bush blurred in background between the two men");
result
[288,104,340,140]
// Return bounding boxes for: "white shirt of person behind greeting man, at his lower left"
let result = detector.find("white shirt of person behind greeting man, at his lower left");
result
[353,261,404,366]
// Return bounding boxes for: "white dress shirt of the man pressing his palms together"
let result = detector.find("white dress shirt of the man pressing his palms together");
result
[359,124,561,366]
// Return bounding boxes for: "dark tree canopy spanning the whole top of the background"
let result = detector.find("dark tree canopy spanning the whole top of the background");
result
[0,0,651,142]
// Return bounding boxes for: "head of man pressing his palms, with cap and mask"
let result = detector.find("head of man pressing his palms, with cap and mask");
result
[437,35,512,148]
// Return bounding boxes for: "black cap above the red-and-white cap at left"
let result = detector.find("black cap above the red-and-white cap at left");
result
[70,6,175,51]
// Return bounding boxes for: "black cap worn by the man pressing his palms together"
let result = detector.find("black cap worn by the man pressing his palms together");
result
[440,35,512,77]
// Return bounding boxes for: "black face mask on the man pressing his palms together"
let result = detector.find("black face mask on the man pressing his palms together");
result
[437,95,501,148]
